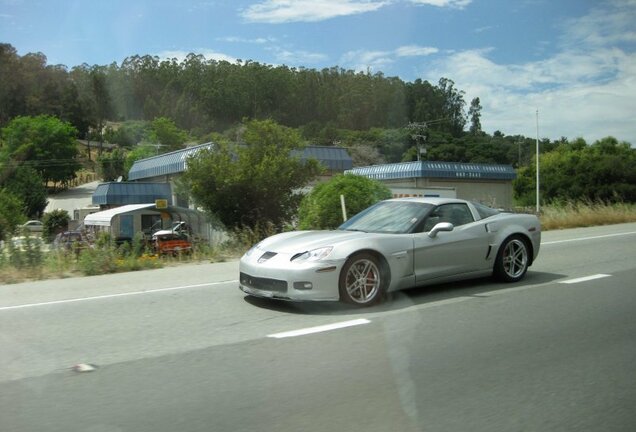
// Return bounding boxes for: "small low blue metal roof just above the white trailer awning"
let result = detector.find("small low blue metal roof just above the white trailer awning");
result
[93,182,172,205]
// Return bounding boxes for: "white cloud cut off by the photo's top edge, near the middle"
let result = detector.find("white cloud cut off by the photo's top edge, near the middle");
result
[241,0,390,24]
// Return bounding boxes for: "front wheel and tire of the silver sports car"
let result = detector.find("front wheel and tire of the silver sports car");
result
[338,253,389,306]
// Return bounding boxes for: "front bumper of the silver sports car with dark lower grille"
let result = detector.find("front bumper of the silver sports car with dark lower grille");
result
[239,255,342,301]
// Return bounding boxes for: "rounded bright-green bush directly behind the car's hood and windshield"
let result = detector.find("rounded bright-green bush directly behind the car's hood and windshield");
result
[298,174,391,229]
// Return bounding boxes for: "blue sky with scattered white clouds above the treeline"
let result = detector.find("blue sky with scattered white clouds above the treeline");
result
[0,0,636,145]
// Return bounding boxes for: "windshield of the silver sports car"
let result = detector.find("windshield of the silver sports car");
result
[338,201,433,234]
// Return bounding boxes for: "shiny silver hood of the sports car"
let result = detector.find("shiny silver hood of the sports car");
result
[258,231,373,254]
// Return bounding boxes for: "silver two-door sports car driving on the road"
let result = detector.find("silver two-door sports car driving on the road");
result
[239,198,541,306]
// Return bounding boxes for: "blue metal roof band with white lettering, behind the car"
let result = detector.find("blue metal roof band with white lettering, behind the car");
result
[346,161,517,180]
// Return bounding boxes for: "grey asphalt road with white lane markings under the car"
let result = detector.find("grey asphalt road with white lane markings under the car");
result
[0,224,636,432]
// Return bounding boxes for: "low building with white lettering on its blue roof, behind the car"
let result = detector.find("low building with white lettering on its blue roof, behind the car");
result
[345,161,516,208]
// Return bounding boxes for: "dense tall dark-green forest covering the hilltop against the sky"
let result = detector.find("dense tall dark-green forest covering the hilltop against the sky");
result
[0,44,466,136]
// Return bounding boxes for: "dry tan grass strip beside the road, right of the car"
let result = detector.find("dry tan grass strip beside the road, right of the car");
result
[540,202,636,231]
